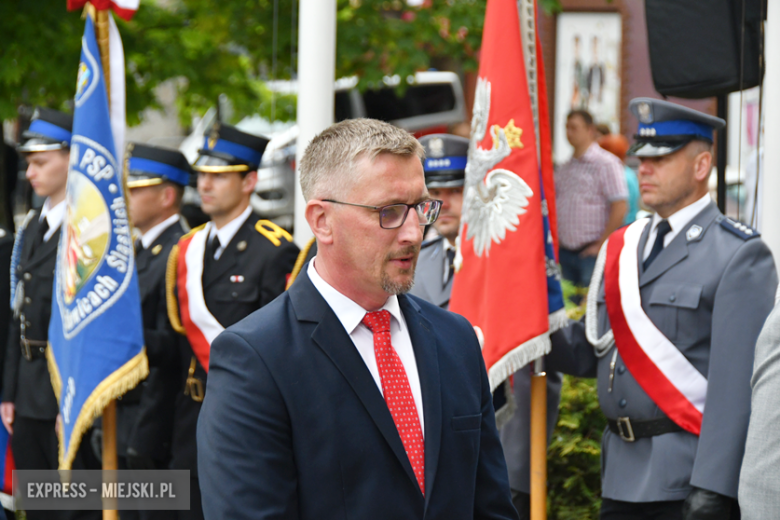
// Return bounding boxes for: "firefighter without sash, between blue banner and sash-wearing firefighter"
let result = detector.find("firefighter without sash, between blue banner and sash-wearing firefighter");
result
[117,143,192,520]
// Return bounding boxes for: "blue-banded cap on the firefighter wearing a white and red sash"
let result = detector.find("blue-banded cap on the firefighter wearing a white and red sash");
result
[192,123,269,173]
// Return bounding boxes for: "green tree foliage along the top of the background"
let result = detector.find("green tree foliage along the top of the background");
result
[0,0,558,124]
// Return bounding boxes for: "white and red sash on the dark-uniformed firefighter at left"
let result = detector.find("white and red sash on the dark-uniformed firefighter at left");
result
[176,222,225,372]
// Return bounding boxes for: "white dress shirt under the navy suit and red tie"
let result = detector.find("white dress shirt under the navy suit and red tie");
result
[306,258,425,436]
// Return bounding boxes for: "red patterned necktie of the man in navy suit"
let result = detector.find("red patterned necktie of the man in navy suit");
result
[363,310,425,496]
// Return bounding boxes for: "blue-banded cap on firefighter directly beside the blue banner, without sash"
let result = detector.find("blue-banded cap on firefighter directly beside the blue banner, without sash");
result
[125,143,192,188]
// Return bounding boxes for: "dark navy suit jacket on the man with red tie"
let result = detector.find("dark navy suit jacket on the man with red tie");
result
[198,267,517,520]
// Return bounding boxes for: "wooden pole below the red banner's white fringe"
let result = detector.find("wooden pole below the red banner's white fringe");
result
[531,358,547,520]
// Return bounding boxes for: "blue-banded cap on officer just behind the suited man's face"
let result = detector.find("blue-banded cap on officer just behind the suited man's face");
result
[420,134,469,188]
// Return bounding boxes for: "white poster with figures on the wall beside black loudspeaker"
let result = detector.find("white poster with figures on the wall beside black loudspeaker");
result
[553,12,622,164]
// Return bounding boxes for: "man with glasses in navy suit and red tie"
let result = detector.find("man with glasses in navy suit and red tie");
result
[198,119,517,520]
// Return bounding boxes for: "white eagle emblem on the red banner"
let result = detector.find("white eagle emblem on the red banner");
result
[455,78,534,262]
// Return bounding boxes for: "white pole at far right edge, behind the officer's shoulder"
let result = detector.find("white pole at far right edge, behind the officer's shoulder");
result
[759,9,780,258]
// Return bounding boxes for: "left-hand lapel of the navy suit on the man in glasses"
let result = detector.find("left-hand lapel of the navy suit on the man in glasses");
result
[289,272,420,492]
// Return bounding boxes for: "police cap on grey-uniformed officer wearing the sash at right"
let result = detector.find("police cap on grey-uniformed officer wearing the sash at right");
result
[626,98,726,157]
